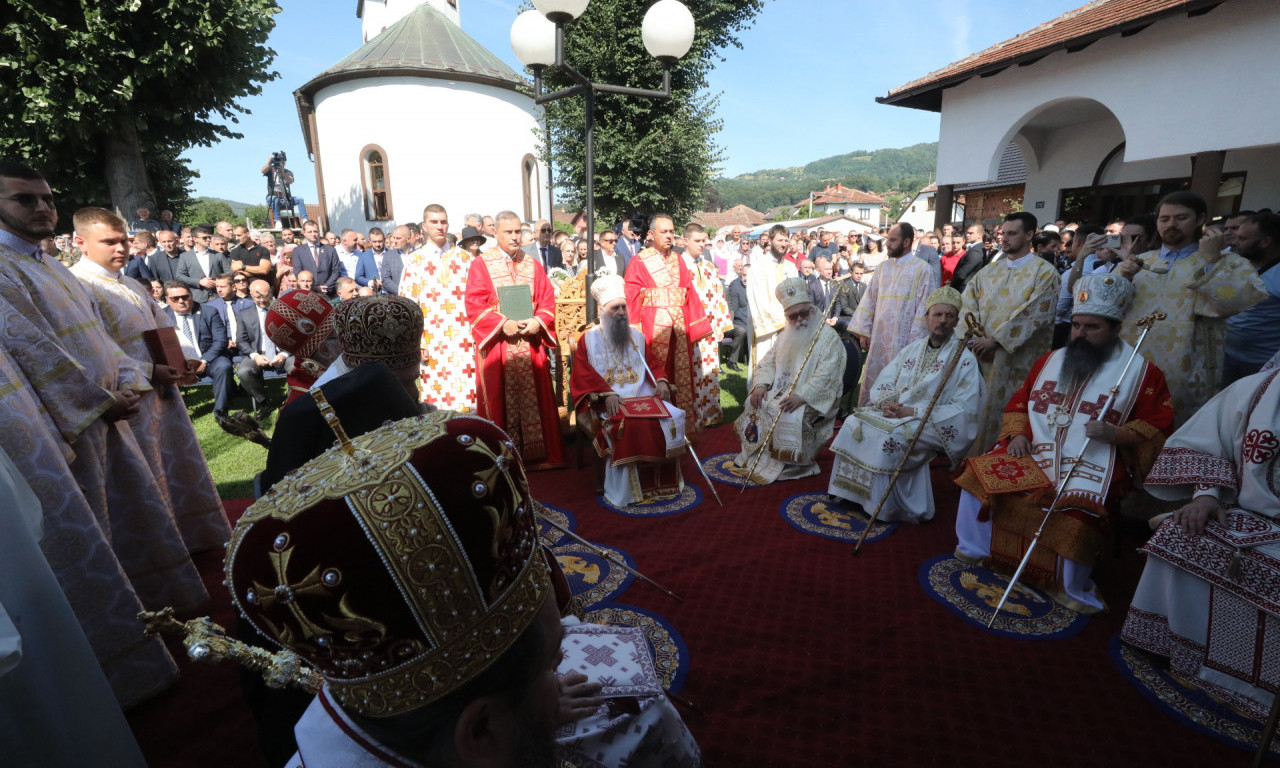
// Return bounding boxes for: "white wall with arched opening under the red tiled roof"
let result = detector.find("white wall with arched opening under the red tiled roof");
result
[938,0,1280,185]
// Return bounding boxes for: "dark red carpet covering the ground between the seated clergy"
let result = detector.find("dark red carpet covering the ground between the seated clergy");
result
[131,426,1249,768]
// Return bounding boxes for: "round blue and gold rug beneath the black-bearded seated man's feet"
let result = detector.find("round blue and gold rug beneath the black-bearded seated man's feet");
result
[920,554,1089,640]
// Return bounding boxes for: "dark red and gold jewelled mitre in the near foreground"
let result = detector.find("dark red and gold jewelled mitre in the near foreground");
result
[225,412,550,717]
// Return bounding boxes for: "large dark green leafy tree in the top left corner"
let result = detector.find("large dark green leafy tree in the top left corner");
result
[0,0,280,225]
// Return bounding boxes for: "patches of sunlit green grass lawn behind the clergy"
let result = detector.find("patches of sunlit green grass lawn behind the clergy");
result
[189,367,746,500]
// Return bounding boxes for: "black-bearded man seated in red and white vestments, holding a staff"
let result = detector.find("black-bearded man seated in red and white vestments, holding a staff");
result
[956,272,1174,613]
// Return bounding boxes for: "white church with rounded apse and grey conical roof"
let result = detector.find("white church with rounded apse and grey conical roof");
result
[293,0,549,232]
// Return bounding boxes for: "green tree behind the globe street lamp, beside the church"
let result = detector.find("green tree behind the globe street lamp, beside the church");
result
[538,0,763,221]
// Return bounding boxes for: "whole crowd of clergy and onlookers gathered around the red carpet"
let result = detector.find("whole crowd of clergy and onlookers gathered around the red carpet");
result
[0,140,1280,765]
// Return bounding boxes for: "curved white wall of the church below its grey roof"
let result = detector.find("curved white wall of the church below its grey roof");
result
[315,77,547,232]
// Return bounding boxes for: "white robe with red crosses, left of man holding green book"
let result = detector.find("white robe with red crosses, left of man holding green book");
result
[398,241,476,413]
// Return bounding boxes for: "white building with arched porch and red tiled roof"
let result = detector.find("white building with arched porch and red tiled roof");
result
[877,0,1280,225]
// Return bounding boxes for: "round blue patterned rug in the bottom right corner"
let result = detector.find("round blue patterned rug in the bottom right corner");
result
[1107,635,1280,759]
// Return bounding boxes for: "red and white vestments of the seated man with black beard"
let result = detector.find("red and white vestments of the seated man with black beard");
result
[956,340,1174,613]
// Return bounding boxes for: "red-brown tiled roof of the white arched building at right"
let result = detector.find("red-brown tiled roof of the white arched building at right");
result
[876,0,1224,111]
